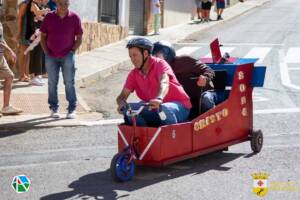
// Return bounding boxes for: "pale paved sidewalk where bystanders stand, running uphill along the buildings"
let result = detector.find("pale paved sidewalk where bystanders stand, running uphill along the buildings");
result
[0,0,271,130]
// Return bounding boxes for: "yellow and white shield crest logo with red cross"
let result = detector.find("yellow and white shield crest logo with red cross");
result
[252,173,269,197]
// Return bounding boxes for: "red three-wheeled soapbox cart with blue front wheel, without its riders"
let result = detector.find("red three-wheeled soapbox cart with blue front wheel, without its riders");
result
[110,39,266,182]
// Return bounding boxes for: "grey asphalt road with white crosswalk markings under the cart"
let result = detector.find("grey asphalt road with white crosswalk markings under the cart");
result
[0,0,300,200]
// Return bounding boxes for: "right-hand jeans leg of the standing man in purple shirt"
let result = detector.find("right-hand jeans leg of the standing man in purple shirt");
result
[62,52,77,113]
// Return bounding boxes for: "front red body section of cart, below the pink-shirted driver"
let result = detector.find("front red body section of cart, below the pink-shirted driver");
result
[118,123,193,166]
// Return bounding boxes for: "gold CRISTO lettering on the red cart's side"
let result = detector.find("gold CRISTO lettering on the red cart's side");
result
[194,108,229,131]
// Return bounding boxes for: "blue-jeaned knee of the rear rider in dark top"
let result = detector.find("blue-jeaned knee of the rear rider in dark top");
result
[199,90,218,114]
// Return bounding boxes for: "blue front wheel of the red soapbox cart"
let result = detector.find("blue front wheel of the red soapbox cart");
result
[110,152,135,182]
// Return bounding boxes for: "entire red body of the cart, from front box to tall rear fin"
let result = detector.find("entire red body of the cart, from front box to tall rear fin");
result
[118,63,254,166]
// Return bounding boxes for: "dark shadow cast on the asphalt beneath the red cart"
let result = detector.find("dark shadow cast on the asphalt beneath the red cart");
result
[41,153,244,200]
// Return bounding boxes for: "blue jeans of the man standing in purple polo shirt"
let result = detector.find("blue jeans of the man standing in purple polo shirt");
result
[45,52,77,112]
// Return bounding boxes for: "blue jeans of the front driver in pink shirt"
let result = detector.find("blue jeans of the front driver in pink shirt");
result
[123,102,190,127]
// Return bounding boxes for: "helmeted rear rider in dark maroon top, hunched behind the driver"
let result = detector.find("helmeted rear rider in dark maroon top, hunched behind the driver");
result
[152,41,217,118]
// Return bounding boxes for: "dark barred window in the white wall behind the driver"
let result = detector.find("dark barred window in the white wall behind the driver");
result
[98,0,119,24]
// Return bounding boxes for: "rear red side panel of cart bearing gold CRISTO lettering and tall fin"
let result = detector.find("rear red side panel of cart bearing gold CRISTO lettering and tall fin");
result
[193,64,253,150]
